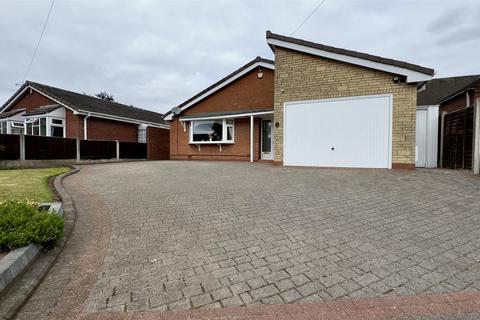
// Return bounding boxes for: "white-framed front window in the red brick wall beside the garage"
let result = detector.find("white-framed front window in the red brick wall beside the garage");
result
[190,119,234,143]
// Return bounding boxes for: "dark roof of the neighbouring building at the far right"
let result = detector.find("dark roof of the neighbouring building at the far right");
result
[417,74,480,106]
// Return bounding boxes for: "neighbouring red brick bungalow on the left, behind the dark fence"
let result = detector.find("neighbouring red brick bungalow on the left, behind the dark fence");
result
[0,81,170,154]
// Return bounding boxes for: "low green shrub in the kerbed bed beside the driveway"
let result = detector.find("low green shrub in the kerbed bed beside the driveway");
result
[0,201,63,251]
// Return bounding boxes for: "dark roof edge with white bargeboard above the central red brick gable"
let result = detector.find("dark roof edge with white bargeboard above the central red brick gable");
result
[165,57,275,118]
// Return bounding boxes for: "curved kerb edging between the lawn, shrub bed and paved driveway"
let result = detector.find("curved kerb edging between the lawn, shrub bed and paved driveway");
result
[0,166,80,319]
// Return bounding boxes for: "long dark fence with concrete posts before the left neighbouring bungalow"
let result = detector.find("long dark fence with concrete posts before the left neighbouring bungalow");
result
[0,134,148,160]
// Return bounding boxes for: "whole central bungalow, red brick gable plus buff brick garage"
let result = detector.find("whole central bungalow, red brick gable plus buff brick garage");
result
[165,31,434,169]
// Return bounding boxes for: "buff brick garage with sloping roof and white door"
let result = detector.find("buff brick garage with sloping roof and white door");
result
[267,31,434,169]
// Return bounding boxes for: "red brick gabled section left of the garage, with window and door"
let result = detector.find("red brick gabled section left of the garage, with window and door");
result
[165,57,274,160]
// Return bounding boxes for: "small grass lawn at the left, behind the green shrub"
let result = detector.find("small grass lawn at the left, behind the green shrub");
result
[0,167,70,202]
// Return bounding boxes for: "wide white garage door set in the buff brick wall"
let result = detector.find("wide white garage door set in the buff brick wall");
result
[283,95,392,168]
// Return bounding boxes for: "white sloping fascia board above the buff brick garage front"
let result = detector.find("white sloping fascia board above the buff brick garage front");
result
[267,39,432,83]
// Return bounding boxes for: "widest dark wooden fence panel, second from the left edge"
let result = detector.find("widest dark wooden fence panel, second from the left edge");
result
[25,135,77,160]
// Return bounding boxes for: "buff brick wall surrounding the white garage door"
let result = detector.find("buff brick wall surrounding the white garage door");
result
[274,47,417,169]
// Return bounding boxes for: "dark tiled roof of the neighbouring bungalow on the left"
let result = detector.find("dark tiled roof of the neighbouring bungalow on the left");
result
[0,81,168,125]
